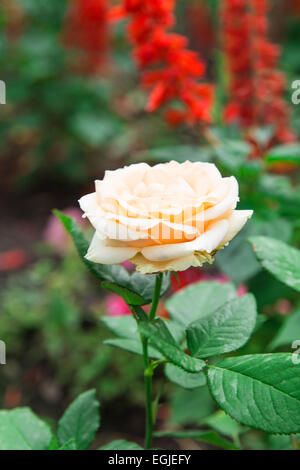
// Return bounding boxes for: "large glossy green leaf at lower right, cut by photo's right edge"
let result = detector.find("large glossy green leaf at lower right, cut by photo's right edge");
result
[208,354,300,434]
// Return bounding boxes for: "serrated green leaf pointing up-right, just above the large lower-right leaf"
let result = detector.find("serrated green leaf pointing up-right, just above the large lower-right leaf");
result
[187,294,256,358]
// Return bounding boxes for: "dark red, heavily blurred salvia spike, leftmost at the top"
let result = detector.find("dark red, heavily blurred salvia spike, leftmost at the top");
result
[63,0,108,74]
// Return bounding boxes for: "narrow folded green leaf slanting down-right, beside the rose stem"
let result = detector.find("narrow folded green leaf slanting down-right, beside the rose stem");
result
[139,319,205,372]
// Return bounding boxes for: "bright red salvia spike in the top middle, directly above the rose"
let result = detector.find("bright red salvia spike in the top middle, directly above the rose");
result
[109,0,213,126]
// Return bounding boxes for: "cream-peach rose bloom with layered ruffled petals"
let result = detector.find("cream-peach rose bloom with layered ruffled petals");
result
[79,161,253,274]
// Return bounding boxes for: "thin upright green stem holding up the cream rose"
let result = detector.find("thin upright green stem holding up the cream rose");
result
[141,273,162,450]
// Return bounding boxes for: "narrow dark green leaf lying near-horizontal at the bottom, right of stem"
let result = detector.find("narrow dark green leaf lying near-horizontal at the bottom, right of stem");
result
[154,429,239,450]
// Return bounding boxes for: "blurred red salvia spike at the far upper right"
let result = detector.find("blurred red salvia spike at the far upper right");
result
[222,0,296,147]
